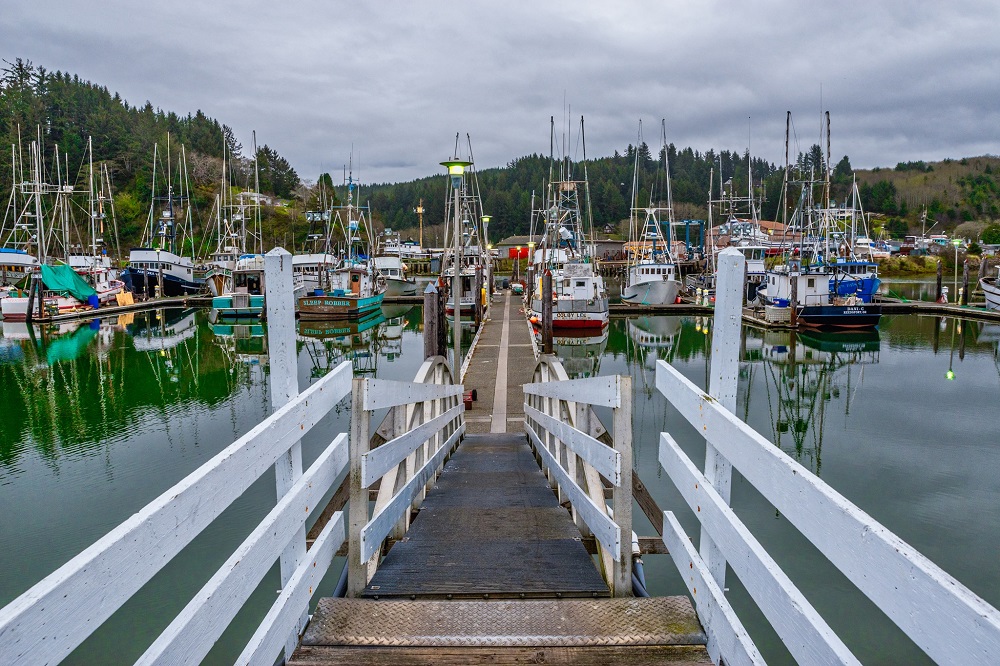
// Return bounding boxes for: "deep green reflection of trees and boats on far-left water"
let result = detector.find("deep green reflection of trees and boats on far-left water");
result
[0,309,254,463]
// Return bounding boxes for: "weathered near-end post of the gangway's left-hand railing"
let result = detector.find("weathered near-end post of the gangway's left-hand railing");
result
[347,378,371,597]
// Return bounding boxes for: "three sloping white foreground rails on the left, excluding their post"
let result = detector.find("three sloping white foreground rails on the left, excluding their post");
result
[0,363,351,664]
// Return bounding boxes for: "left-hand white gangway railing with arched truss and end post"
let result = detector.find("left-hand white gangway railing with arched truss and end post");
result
[347,356,465,596]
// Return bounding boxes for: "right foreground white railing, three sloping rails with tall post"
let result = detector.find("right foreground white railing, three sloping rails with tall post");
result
[656,245,1000,664]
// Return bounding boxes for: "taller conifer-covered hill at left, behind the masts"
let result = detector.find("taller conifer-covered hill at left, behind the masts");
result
[0,59,299,246]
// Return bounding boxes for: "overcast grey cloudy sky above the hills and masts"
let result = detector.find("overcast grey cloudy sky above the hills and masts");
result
[0,0,1000,183]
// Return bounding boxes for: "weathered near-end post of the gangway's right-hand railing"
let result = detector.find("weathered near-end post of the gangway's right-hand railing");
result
[612,377,632,597]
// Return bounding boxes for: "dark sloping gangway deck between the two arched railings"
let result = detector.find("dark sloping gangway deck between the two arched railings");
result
[364,434,608,598]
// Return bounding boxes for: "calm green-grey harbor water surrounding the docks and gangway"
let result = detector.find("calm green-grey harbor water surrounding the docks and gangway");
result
[0,306,1000,664]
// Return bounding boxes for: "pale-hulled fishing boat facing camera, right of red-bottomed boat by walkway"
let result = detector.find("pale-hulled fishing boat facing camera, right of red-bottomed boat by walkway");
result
[622,121,681,305]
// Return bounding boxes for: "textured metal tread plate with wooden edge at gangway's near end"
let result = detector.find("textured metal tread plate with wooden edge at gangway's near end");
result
[289,597,711,664]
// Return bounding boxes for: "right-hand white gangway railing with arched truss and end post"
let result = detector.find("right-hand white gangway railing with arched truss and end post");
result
[524,355,632,596]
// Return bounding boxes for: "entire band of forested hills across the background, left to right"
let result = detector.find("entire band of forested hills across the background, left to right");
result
[0,59,1000,256]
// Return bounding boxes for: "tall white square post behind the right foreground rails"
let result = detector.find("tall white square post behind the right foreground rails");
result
[700,248,746,589]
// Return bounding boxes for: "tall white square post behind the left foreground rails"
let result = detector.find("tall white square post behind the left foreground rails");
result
[264,247,309,658]
